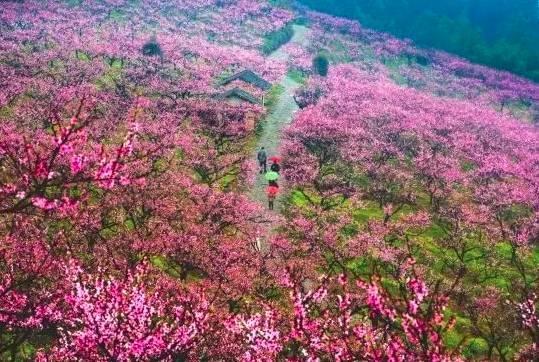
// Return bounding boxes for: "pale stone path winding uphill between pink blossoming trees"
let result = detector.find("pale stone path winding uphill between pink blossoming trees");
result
[249,25,309,215]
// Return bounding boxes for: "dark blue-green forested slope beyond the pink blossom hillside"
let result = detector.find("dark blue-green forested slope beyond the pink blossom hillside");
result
[300,0,539,81]
